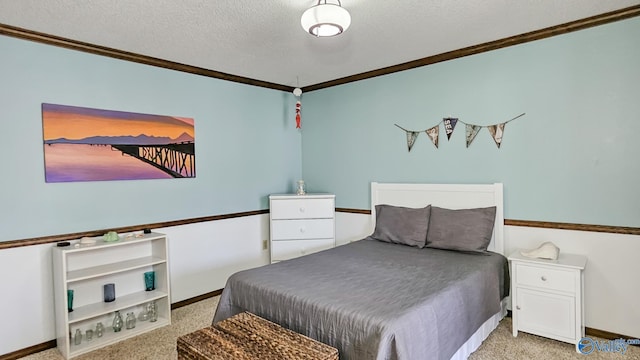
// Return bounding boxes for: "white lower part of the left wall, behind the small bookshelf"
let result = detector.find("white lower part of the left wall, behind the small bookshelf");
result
[0,214,269,355]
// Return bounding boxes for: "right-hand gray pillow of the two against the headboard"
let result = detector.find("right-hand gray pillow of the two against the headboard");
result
[427,206,496,253]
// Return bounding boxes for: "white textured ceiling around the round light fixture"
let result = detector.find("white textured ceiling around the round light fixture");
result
[0,0,640,87]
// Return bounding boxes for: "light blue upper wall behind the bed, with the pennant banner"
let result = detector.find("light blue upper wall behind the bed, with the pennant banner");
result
[302,18,640,227]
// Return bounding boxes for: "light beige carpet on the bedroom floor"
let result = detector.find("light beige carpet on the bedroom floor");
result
[17,297,640,360]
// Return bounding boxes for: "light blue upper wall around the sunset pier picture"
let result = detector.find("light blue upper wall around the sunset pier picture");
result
[0,36,301,241]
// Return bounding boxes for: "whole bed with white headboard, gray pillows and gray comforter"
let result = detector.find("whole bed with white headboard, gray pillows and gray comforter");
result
[213,183,509,360]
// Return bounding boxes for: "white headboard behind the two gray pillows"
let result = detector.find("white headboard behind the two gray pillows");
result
[371,182,504,254]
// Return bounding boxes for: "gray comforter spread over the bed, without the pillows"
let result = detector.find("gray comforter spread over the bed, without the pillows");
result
[213,238,509,360]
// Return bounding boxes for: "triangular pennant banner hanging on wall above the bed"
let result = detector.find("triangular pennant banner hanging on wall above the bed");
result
[394,113,524,151]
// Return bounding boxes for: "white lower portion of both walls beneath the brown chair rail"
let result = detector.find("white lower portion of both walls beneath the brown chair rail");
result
[0,212,640,355]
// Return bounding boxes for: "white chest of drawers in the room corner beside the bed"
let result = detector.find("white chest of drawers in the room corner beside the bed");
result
[269,194,336,263]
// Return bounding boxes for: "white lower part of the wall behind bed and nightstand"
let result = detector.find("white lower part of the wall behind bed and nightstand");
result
[336,212,640,338]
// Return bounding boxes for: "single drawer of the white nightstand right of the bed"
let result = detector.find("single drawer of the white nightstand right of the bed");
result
[516,264,577,293]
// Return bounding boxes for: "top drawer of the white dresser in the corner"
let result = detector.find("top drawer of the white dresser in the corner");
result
[270,199,335,219]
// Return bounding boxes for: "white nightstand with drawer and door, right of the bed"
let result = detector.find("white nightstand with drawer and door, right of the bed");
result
[509,250,587,350]
